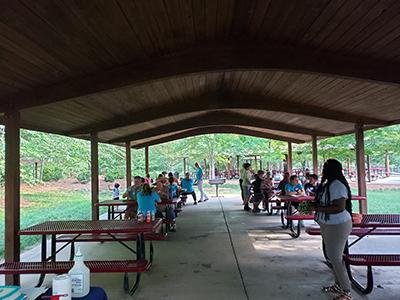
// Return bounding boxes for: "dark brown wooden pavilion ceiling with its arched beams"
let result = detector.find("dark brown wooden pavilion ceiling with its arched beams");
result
[0,0,400,147]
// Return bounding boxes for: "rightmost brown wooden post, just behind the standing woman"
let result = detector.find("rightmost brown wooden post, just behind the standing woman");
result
[355,124,368,214]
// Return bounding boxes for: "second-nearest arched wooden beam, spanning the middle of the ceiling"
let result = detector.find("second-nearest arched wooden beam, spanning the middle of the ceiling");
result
[68,91,388,135]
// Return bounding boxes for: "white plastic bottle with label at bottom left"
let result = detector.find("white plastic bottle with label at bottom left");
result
[68,247,90,298]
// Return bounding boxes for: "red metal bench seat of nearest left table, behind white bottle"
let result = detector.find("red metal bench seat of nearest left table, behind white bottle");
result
[0,259,151,295]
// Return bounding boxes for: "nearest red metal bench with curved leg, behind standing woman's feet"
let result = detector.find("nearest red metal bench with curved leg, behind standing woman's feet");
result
[343,254,400,294]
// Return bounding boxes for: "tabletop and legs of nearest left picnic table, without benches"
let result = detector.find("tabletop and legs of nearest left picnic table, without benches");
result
[18,219,162,289]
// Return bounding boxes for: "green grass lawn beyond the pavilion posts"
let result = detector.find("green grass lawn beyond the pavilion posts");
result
[0,183,400,257]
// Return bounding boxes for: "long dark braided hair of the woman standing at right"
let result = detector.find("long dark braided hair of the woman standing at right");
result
[315,159,352,219]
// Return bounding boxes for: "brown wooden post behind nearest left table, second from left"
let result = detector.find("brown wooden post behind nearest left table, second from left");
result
[90,133,99,220]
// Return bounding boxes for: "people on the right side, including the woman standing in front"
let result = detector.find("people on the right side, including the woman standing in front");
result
[240,159,353,300]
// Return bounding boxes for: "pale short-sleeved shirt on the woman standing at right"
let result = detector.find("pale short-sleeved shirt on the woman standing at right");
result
[316,179,351,225]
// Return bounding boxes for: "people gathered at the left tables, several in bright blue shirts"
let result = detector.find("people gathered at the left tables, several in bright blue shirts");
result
[109,163,208,219]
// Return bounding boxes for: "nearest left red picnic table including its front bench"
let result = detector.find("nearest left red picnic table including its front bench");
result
[0,219,161,294]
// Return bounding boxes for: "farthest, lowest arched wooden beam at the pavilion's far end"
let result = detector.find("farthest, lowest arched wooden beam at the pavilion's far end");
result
[132,126,304,149]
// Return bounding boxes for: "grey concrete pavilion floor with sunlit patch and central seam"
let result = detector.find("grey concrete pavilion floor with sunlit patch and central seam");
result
[0,197,400,300]
